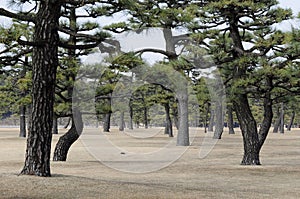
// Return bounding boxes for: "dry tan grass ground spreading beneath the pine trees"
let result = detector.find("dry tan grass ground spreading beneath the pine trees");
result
[0,128,300,199]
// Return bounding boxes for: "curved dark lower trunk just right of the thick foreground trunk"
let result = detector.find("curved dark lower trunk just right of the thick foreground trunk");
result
[53,110,83,161]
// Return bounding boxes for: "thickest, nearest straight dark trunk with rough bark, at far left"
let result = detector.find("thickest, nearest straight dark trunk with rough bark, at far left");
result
[21,0,61,176]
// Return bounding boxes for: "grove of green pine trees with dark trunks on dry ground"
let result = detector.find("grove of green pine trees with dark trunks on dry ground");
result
[0,0,300,176]
